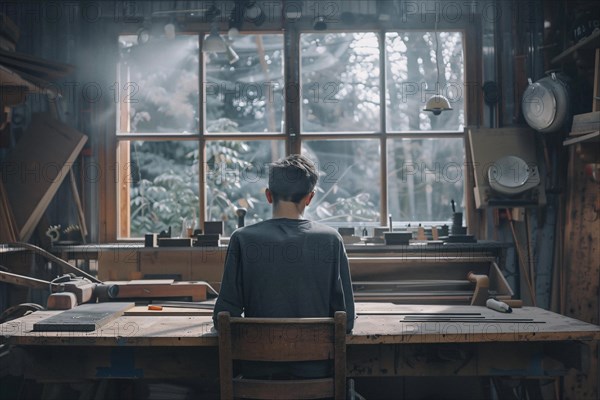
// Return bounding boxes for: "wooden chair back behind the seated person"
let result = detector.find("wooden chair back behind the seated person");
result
[218,311,346,400]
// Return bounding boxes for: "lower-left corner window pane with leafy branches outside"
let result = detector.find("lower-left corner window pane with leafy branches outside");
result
[126,141,199,237]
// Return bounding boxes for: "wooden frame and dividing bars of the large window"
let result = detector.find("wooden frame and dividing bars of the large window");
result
[99,19,482,242]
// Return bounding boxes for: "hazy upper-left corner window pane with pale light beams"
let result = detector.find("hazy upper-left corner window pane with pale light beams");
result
[118,35,199,133]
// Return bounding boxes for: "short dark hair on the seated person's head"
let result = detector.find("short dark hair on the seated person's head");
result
[269,154,319,203]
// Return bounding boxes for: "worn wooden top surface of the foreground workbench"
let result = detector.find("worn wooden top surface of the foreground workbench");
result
[0,303,600,346]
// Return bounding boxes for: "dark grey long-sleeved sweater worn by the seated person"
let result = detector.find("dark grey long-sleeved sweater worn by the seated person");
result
[213,218,355,331]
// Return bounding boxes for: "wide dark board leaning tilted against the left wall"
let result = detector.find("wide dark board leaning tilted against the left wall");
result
[2,114,87,241]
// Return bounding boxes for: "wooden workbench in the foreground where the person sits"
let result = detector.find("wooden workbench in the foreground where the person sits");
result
[0,303,600,381]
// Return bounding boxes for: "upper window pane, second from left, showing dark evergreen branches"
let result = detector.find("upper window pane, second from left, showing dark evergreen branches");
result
[202,34,284,133]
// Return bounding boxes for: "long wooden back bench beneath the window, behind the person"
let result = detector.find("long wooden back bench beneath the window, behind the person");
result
[52,241,508,284]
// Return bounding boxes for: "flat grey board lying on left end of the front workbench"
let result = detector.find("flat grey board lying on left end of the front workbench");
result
[33,303,135,332]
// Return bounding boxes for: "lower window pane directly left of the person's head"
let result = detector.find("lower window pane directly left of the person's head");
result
[206,140,285,236]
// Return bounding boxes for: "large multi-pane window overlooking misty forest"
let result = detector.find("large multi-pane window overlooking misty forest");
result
[117,31,465,238]
